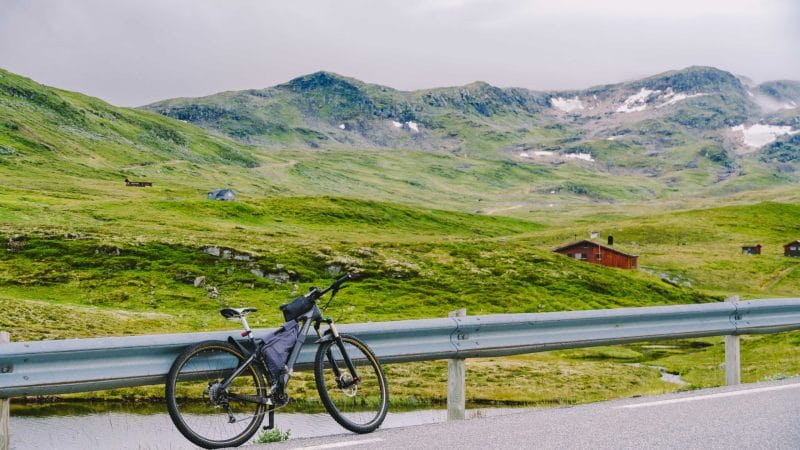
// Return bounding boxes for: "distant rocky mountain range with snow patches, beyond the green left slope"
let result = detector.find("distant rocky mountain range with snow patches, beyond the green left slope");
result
[144,67,800,197]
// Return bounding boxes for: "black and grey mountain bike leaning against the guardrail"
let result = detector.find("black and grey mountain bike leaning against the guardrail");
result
[165,274,389,448]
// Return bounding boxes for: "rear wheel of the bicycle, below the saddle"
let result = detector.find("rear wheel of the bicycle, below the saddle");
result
[165,341,267,448]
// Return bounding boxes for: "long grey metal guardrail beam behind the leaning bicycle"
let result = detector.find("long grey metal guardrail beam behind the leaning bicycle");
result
[0,298,800,398]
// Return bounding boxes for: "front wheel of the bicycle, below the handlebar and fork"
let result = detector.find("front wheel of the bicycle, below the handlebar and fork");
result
[314,334,389,433]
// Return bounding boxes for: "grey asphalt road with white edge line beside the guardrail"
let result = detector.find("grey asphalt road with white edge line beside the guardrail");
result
[264,378,800,450]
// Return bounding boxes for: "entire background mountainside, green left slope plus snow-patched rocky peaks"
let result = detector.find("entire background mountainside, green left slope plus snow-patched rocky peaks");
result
[0,67,800,217]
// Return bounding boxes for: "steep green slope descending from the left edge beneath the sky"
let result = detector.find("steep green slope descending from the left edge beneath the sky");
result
[0,70,259,189]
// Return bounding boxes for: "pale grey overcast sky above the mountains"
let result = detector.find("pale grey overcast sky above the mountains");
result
[0,0,800,106]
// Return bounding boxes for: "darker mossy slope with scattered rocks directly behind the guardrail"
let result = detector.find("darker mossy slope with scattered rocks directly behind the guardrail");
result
[0,226,711,337]
